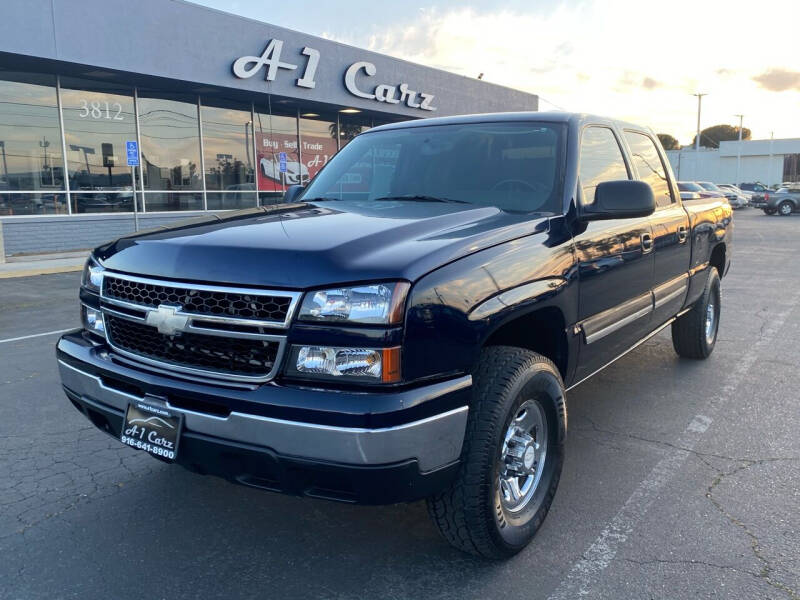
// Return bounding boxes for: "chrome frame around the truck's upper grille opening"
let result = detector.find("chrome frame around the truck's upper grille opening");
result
[100,271,303,329]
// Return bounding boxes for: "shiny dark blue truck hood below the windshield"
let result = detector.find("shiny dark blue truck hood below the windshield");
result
[95,201,548,289]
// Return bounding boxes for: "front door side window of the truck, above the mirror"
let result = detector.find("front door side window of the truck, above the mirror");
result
[578,127,629,204]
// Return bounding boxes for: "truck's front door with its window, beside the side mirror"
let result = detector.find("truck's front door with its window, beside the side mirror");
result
[574,125,653,379]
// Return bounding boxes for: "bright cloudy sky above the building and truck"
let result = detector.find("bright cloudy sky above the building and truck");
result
[195,0,800,144]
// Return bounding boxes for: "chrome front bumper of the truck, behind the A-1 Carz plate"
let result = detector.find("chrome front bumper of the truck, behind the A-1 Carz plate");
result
[58,360,469,471]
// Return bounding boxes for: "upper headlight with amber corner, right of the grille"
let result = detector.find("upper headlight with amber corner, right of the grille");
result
[298,281,410,325]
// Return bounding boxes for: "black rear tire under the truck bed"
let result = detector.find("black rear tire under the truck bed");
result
[672,267,722,360]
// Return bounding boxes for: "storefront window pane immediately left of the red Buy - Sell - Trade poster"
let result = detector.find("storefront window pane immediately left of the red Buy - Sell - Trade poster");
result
[200,99,256,210]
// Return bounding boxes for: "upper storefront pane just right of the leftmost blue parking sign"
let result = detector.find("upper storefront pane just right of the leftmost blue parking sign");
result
[139,92,203,191]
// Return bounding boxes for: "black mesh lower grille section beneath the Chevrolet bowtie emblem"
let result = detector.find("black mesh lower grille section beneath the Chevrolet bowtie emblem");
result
[105,314,280,377]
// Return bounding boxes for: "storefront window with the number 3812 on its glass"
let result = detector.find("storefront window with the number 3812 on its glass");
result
[61,77,136,213]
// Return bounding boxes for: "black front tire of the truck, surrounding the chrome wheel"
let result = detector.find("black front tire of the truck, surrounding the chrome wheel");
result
[427,346,567,559]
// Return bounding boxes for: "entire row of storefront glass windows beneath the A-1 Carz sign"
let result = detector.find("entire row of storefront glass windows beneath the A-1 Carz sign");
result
[0,69,404,216]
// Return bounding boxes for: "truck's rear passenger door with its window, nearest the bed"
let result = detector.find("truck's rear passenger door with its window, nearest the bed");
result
[624,130,691,329]
